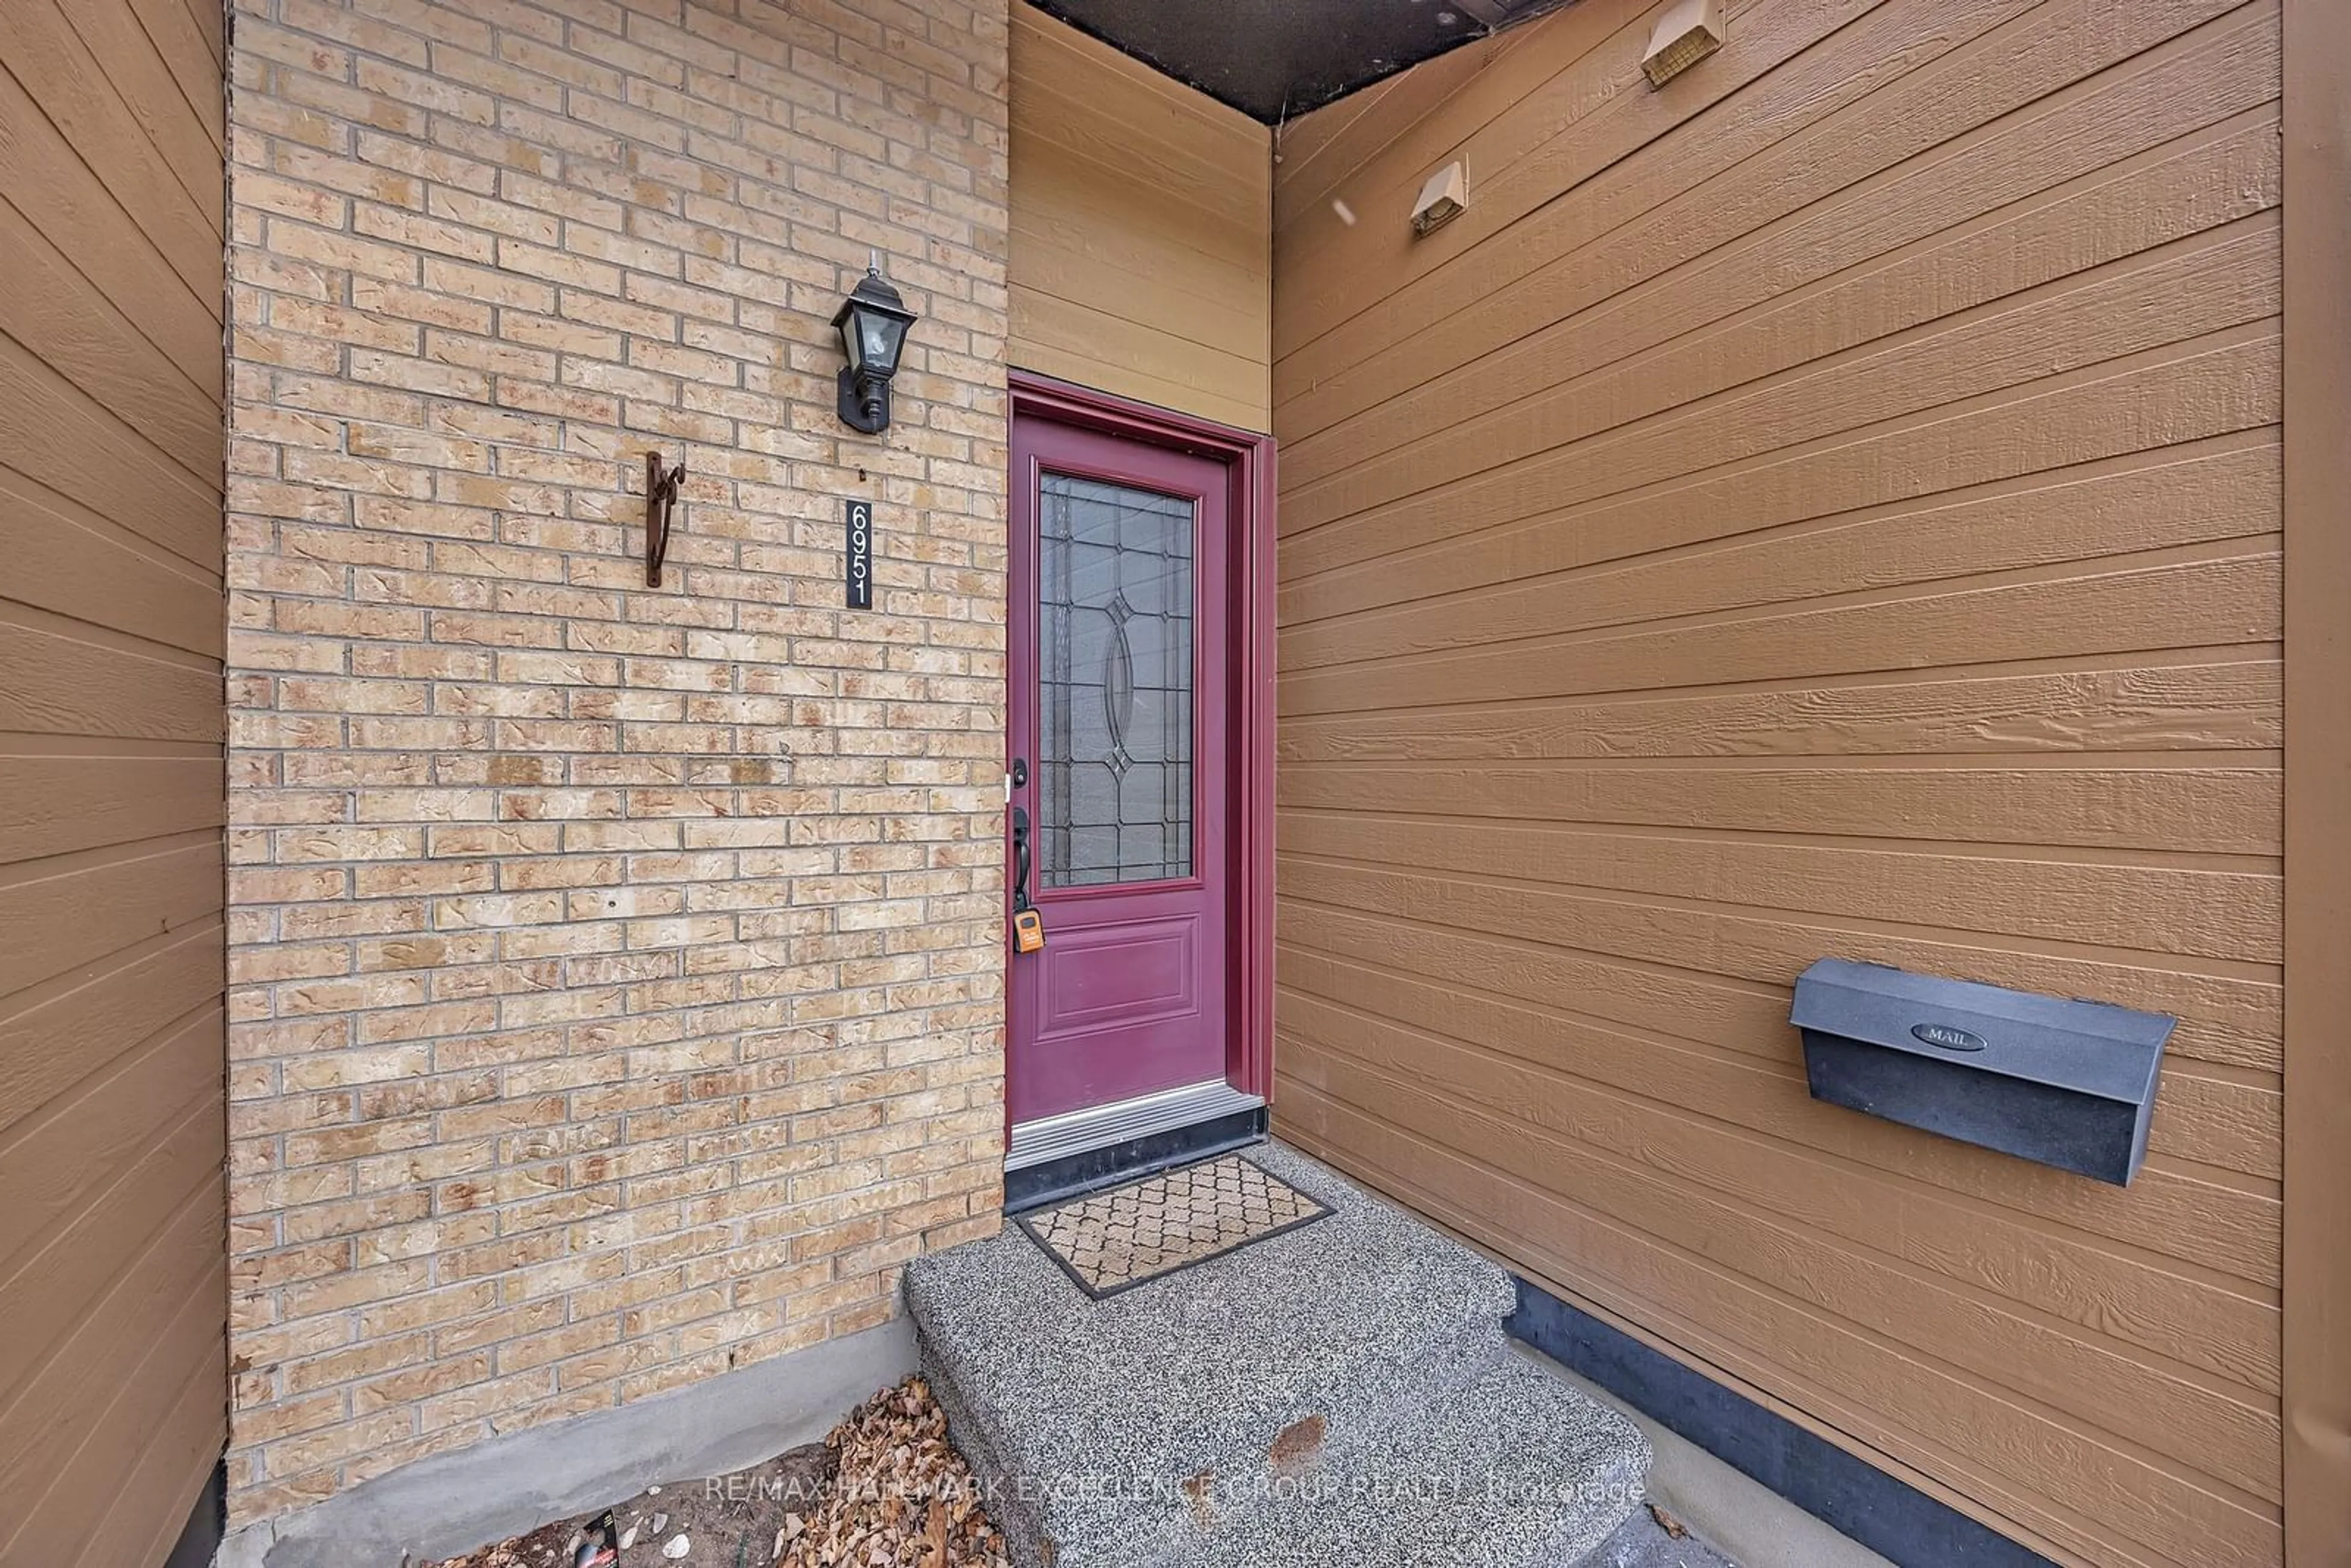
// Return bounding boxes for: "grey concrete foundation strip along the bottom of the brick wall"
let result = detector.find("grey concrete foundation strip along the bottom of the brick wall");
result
[214,1316,915,1568]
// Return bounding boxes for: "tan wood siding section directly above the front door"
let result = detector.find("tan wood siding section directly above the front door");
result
[1008,5,1272,430]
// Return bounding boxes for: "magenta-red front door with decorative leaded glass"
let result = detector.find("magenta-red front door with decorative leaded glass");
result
[1007,418,1234,1126]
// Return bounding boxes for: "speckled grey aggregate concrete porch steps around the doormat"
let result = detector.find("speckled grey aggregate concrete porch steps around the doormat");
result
[905,1145,1651,1568]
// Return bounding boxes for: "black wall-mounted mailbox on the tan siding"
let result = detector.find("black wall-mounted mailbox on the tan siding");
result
[1789,959,2180,1187]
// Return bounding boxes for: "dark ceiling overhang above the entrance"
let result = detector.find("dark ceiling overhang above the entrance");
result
[1037,0,1568,124]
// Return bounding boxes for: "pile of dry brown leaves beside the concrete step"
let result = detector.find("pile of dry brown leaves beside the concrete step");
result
[776,1378,1011,1568]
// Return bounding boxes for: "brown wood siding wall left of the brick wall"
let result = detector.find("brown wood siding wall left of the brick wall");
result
[0,0,228,1568]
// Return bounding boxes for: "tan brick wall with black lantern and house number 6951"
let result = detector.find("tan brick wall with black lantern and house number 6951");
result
[228,0,1007,1523]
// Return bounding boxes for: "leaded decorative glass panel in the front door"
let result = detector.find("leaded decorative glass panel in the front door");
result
[1037,473,1194,888]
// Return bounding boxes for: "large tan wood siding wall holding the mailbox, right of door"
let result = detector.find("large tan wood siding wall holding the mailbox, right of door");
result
[1274,0,2285,1568]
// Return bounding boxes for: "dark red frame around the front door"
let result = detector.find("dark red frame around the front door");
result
[1004,369,1274,1114]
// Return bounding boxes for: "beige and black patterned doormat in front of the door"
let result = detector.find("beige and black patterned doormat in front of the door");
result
[1013,1154,1330,1300]
